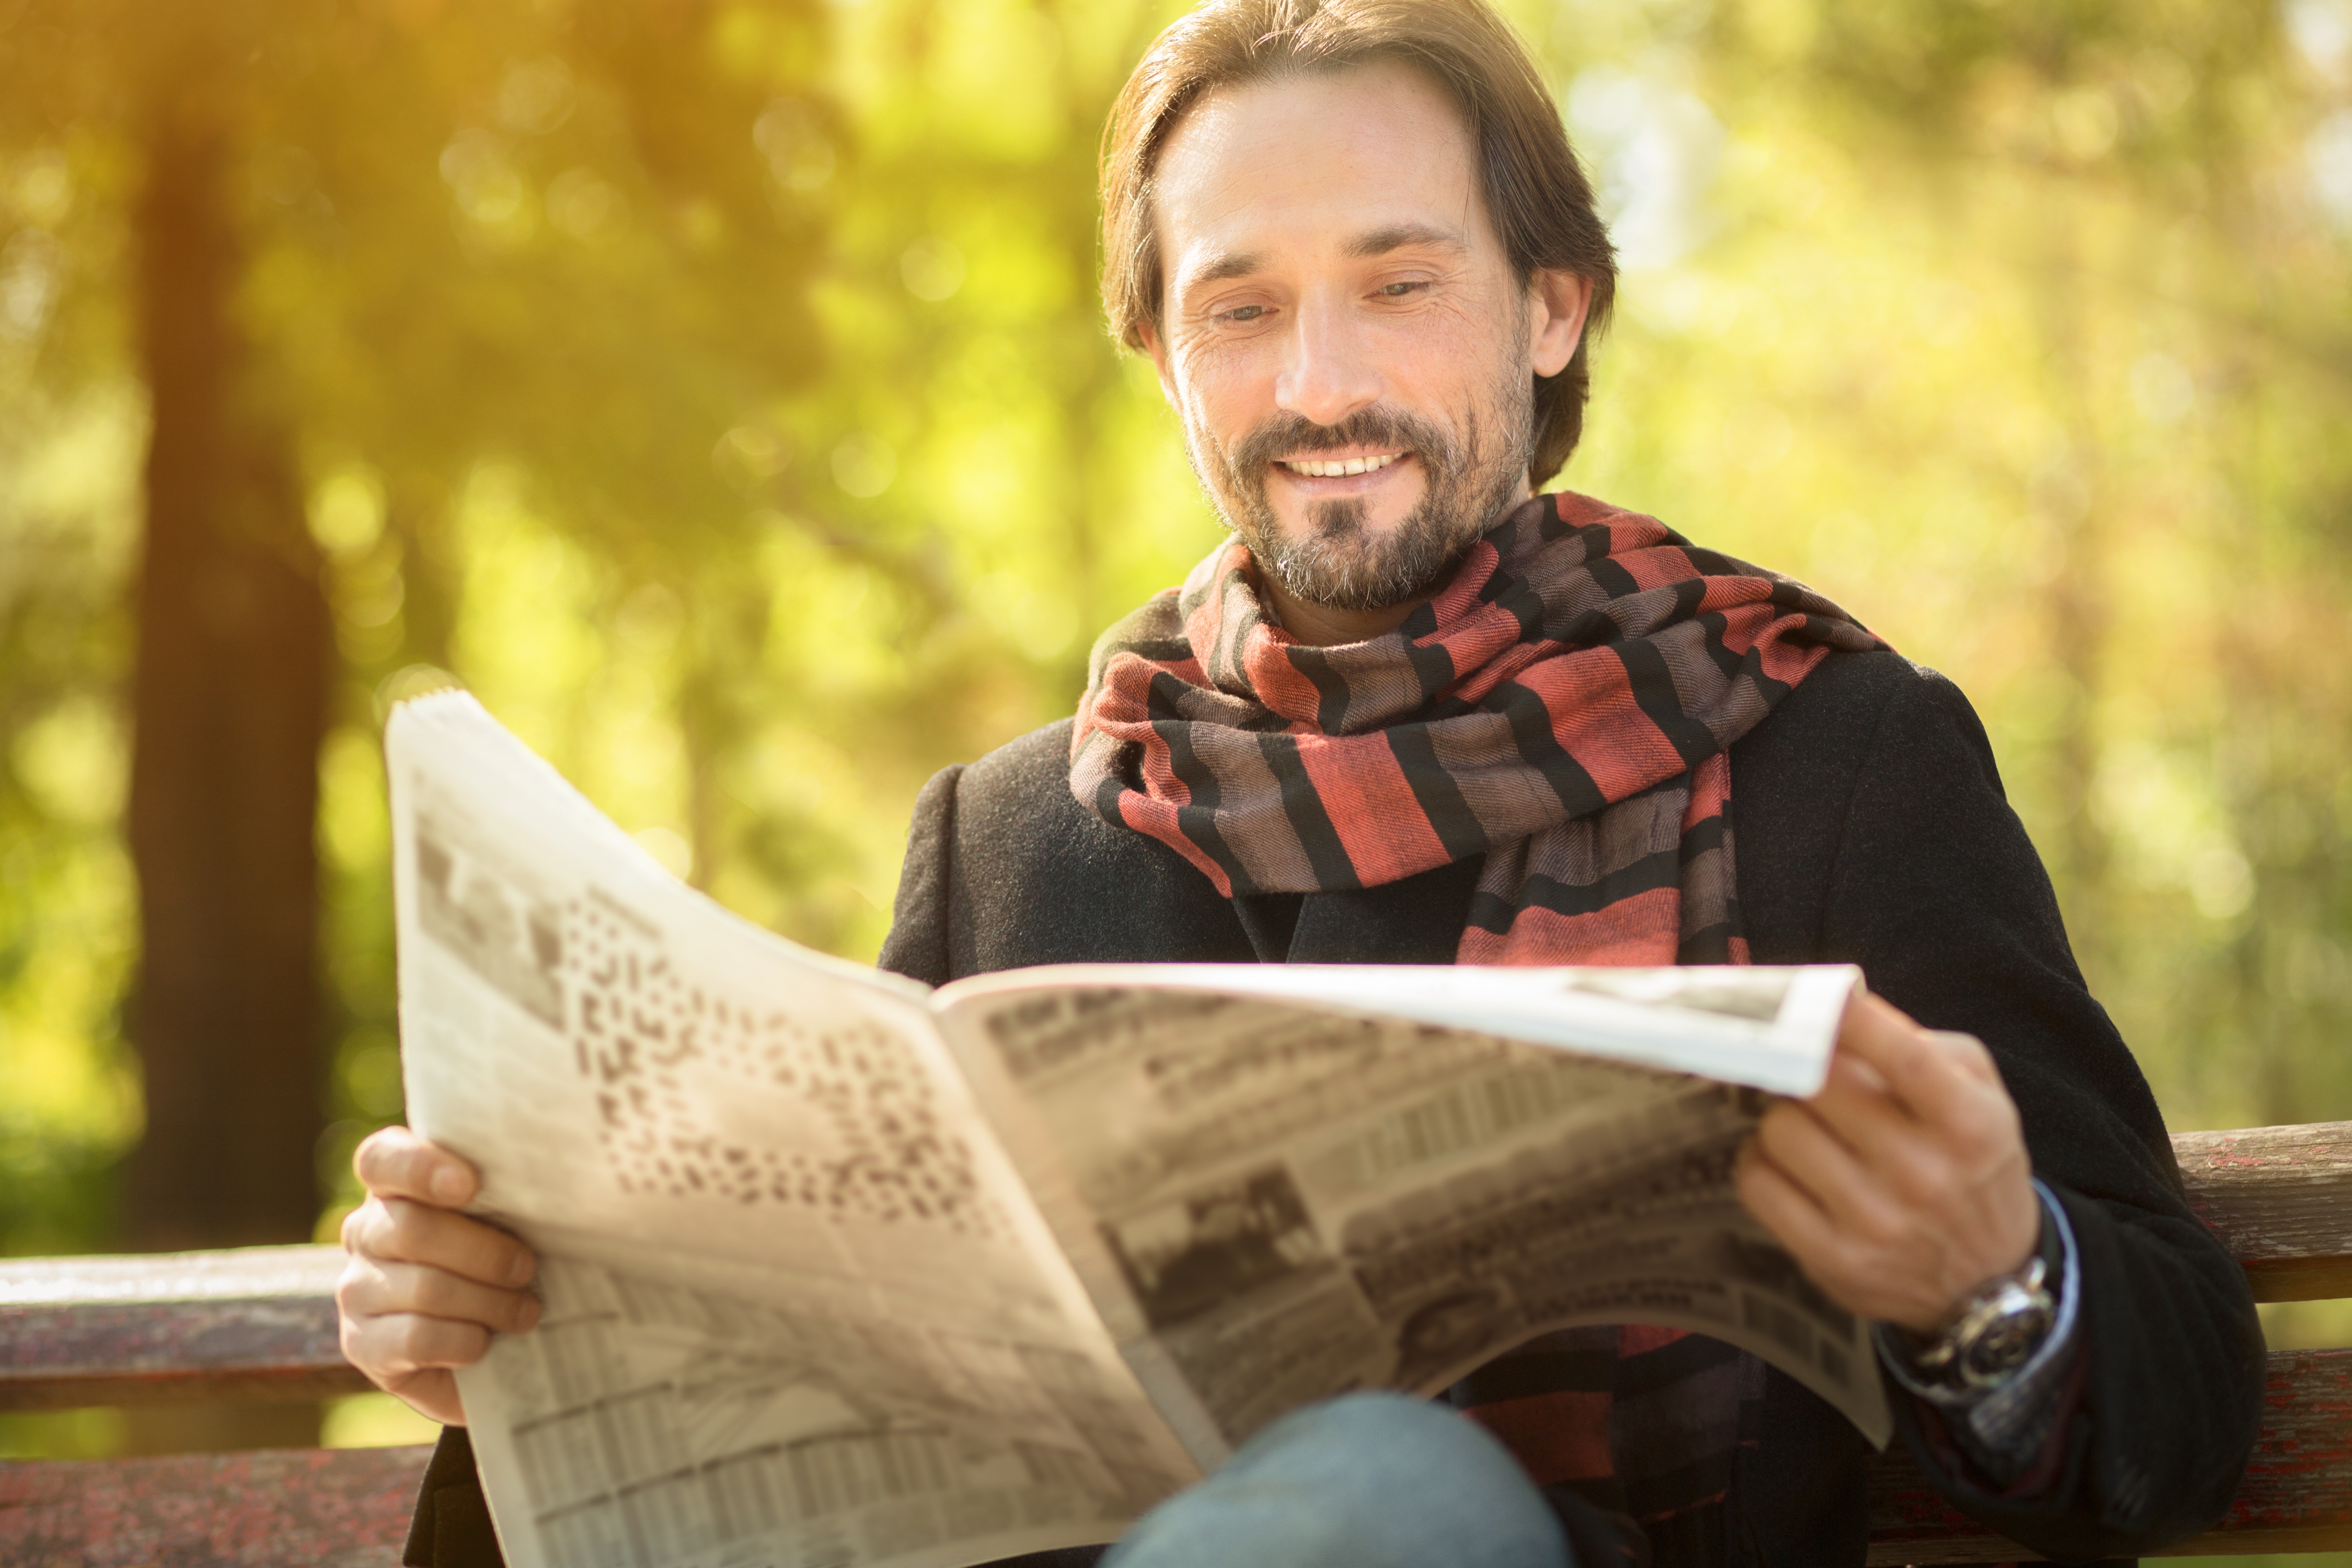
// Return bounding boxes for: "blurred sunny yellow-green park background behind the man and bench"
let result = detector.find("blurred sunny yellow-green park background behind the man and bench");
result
[0,0,2352,1523]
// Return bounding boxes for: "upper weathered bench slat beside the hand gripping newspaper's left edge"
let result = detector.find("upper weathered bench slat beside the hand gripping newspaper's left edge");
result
[0,1246,370,1411]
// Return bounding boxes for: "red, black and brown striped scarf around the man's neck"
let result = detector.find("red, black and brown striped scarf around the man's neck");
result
[1070,491,1884,1566]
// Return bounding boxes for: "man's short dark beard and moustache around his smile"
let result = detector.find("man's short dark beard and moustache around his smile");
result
[1185,367,1536,611]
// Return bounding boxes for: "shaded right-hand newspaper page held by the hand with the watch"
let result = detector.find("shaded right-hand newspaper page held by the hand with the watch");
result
[939,966,1891,1465]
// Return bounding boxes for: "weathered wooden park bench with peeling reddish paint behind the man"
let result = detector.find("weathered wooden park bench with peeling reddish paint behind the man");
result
[0,1121,2352,1568]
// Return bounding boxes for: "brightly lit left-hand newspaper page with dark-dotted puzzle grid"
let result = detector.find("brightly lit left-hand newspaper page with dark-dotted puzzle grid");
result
[388,694,1195,1568]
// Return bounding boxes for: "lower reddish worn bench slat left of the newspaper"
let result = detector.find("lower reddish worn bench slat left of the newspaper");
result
[0,1448,433,1568]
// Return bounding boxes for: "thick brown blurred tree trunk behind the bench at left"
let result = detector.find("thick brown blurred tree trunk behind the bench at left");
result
[127,73,332,1251]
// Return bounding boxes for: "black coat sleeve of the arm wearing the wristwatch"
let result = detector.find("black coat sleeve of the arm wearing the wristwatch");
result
[1818,672,2263,1561]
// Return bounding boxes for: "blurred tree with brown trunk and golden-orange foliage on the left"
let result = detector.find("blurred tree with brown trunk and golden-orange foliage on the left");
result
[0,0,837,1278]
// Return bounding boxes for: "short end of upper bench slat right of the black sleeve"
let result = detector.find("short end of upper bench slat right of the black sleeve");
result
[2173,1121,2352,1302]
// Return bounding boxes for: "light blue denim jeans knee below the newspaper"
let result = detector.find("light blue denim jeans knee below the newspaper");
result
[1103,1394,1576,1568]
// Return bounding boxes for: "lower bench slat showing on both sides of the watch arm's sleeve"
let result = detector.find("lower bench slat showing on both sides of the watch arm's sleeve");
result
[1870,1350,2352,1568]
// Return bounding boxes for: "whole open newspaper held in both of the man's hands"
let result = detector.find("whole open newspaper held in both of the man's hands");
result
[388,694,1889,1568]
